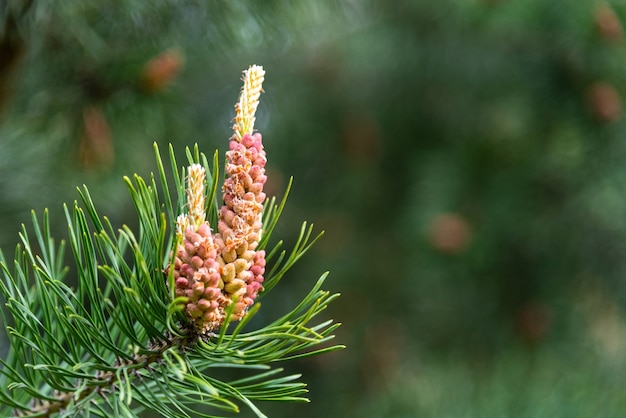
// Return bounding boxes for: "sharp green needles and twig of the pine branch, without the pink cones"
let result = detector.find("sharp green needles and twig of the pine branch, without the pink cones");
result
[0,146,342,417]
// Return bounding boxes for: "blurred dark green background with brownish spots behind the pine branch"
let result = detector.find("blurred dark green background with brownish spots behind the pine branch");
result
[0,0,626,418]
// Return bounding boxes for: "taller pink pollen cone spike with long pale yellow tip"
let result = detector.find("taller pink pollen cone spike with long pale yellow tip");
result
[211,65,267,320]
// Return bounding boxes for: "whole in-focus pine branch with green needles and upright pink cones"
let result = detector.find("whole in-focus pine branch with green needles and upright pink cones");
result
[0,67,343,418]
